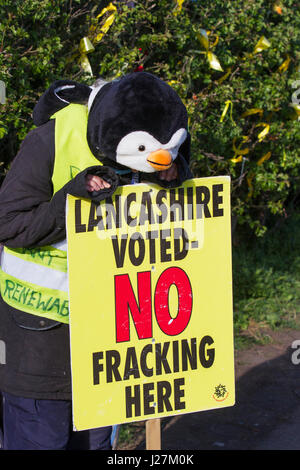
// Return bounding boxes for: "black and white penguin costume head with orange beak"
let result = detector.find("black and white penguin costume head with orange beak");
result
[33,72,189,173]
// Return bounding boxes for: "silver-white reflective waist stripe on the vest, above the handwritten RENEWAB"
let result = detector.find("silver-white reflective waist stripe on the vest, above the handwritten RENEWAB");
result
[1,248,68,292]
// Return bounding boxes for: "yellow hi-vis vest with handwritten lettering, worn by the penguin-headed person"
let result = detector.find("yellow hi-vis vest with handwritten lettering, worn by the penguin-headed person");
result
[0,104,101,323]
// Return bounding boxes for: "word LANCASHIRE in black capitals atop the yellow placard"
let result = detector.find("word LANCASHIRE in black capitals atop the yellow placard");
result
[75,184,224,236]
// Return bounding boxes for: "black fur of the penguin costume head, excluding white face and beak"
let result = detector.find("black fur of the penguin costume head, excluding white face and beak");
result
[33,72,190,175]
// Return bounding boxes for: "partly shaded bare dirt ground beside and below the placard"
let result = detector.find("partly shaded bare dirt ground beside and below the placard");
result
[118,322,300,450]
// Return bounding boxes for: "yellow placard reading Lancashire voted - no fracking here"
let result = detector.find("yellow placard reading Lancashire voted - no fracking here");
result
[67,177,235,430]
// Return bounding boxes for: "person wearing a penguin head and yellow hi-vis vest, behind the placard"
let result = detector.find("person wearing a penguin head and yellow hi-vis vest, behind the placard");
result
[0,72,192,449]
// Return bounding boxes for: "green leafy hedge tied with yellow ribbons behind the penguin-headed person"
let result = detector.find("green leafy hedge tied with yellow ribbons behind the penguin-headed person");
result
[0,0,300,235]
